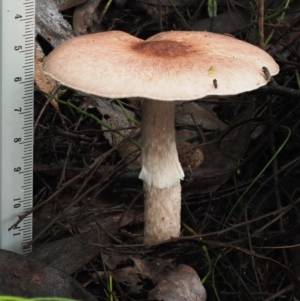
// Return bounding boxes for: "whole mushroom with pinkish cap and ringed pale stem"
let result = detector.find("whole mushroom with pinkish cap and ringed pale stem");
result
[44,31,279,244]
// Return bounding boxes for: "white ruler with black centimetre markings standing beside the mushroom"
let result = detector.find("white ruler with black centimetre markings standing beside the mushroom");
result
[0,0,35,254]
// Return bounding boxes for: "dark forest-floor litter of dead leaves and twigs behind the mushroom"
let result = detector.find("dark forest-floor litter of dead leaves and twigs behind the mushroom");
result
[9,0,300,301]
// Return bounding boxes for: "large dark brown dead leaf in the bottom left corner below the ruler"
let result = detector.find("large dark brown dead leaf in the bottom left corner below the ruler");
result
[0,250,97,301]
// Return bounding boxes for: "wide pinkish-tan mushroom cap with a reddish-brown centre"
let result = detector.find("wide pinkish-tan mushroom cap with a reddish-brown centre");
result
[44,31,279,101]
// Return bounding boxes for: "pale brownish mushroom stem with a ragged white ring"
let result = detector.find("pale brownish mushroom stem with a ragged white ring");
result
[139,99,184,244]
